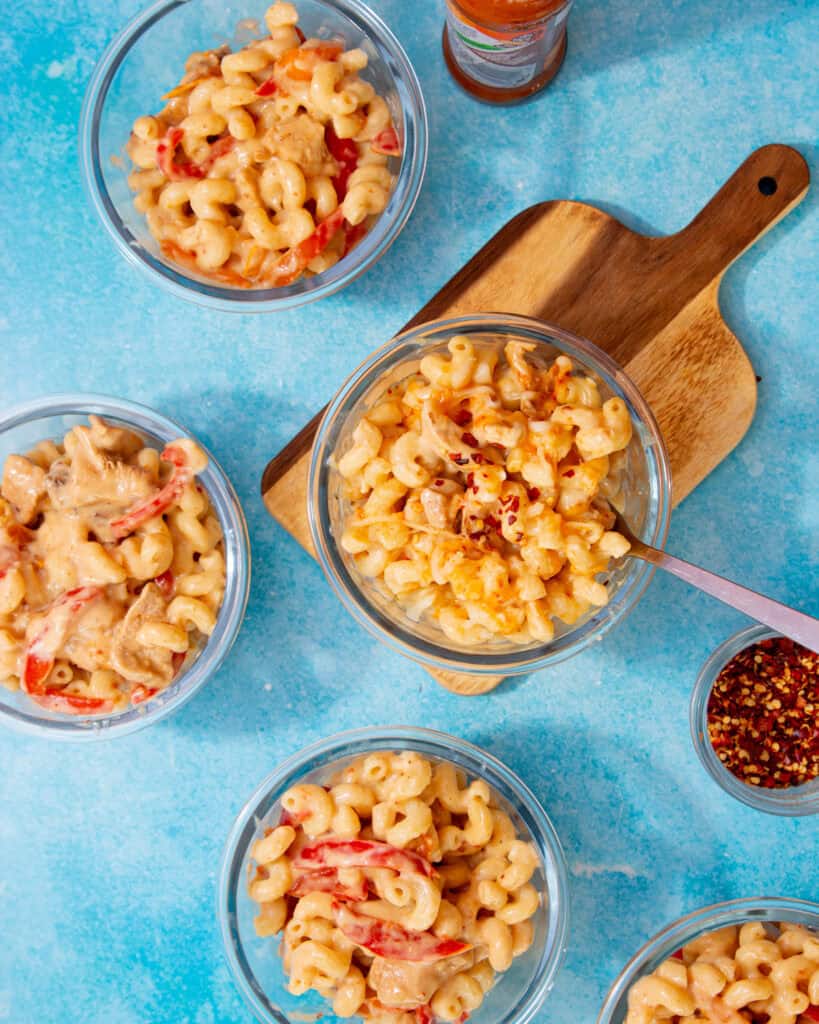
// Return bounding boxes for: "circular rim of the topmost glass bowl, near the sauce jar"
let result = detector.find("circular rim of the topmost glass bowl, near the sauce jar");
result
[79,0,429,313]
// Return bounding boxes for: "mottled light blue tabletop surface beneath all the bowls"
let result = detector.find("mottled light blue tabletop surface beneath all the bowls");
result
[0,0,819,1024]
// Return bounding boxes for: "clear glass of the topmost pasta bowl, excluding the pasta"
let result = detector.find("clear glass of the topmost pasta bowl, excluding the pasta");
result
[80,0,428,312]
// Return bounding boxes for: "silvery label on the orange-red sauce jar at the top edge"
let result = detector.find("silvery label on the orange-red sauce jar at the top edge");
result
[446,2,571,89]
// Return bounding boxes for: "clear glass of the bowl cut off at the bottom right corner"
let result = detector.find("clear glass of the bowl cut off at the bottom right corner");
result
[597,896,819,1024]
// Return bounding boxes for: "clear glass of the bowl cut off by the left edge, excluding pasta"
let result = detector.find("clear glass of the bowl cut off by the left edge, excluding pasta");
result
[0,394,250,740]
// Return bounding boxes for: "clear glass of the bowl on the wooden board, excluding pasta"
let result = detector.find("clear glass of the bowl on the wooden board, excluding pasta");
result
[307,313,671,676]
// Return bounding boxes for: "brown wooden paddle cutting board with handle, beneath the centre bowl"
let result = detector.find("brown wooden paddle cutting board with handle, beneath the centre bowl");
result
[261,145,810,694]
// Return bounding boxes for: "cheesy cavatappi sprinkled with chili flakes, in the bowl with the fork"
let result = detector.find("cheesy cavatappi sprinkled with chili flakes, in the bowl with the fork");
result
[335,336,632,645]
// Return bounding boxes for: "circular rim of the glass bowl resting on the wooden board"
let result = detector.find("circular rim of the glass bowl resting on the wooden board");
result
[307,312,672,676]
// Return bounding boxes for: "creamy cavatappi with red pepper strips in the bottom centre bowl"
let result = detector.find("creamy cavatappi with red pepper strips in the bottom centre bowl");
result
[249,752,542,1024]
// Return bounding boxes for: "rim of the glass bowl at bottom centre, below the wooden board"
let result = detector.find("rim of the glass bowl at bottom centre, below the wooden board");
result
[221,725,571,1024]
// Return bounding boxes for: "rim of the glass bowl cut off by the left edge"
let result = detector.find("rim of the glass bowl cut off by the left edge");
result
[0,391,251,742]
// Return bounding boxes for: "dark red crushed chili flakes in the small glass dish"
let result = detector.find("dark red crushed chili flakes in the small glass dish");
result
[708,637,819,790]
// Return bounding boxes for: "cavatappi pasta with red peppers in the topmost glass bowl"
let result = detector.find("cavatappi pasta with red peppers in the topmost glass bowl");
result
[126,3,400,288]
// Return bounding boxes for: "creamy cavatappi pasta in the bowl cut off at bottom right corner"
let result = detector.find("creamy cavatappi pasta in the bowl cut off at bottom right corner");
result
[626,921,819,1024]
